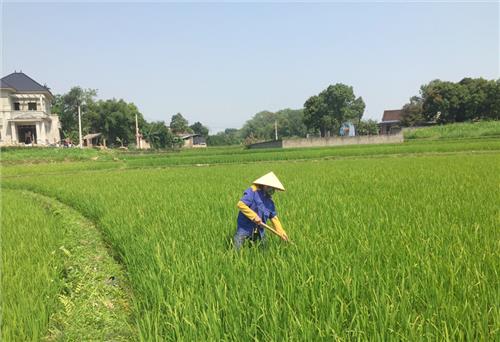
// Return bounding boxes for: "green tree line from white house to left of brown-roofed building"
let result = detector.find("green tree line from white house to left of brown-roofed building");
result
[52,84,376,148]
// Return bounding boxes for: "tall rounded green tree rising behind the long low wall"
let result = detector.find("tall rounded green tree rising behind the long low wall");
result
[304,83,365,136]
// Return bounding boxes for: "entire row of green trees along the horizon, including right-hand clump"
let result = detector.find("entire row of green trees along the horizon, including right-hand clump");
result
[53,78,500,148]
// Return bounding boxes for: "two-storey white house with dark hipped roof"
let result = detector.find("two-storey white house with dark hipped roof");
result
[0,72,60,146]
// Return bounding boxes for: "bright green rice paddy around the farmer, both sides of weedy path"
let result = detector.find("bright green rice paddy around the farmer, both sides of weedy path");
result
[1,138,500,341]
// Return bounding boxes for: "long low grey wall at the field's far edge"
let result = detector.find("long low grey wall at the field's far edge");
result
[283,134,404,148]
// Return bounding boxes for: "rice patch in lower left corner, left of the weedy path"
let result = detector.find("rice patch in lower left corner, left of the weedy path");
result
[1,189,65,341]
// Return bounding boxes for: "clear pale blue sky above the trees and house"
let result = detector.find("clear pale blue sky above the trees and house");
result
[1,2,500,132]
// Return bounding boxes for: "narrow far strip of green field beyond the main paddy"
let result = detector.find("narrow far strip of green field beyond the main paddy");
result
[1,138,500,177]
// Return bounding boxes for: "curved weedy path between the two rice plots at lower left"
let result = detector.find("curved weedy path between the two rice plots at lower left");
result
[14,190,136,341]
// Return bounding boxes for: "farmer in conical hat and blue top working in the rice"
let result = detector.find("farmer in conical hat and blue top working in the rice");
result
[234,172,288,250]
